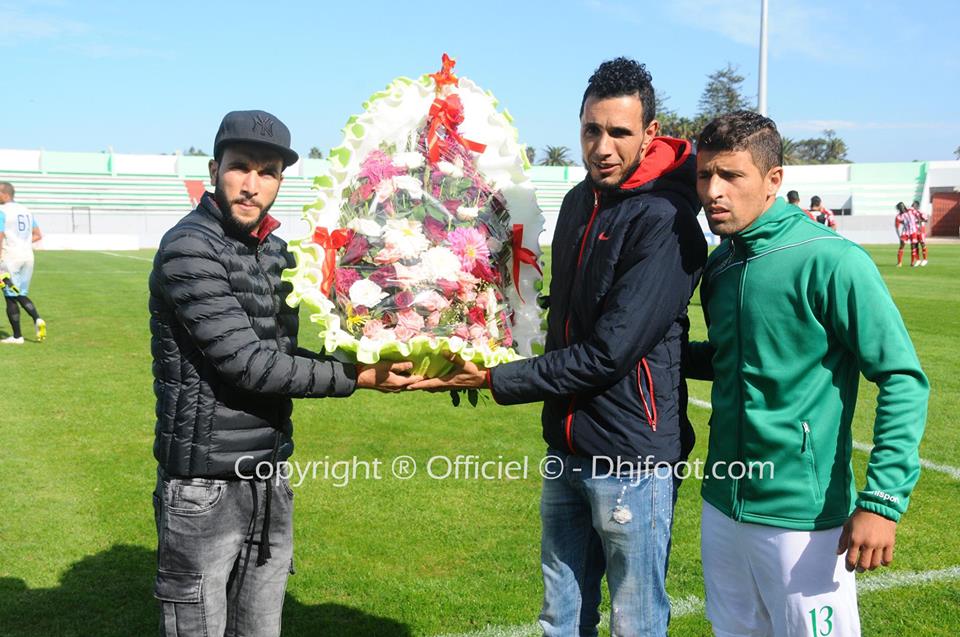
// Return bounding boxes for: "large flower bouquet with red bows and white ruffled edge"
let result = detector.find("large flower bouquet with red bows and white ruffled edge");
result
[284,55,543,376]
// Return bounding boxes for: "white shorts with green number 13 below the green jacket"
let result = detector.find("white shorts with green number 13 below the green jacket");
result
[700,502,860,637]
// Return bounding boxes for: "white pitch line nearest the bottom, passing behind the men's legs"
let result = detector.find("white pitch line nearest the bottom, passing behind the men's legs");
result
[440,566,960,637]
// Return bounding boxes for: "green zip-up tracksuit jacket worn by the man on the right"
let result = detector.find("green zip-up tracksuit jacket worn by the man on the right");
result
[685,199,929,530]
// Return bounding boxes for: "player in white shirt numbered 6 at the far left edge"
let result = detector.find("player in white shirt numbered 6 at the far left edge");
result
[0,181,47,345]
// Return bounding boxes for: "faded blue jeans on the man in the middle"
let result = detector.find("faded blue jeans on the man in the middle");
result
[540,449,676,637]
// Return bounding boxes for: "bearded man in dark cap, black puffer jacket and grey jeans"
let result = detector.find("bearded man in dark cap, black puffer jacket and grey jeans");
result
[150,111,416,637]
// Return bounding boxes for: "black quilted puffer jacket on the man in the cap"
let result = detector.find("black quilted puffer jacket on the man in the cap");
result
[150,194,356,478]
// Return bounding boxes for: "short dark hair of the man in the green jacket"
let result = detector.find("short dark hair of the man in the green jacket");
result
[697,110,783,175]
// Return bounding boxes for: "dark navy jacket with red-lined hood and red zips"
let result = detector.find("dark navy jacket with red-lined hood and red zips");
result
[489,138,707,466]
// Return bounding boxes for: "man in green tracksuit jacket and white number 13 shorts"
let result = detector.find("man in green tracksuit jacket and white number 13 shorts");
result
[685,111,929,637]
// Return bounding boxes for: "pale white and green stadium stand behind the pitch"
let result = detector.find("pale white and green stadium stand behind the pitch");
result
[0,149,960,249]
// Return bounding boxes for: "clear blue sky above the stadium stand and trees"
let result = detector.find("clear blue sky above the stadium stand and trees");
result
[0,0,960,161]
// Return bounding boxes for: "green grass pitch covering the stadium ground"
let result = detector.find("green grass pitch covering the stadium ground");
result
[0,245,960,637]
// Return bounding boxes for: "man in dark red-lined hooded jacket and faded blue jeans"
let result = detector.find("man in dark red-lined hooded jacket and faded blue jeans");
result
[411,58,707,637]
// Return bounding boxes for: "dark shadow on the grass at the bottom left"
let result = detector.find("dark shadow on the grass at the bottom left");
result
[0,545,411,637]
